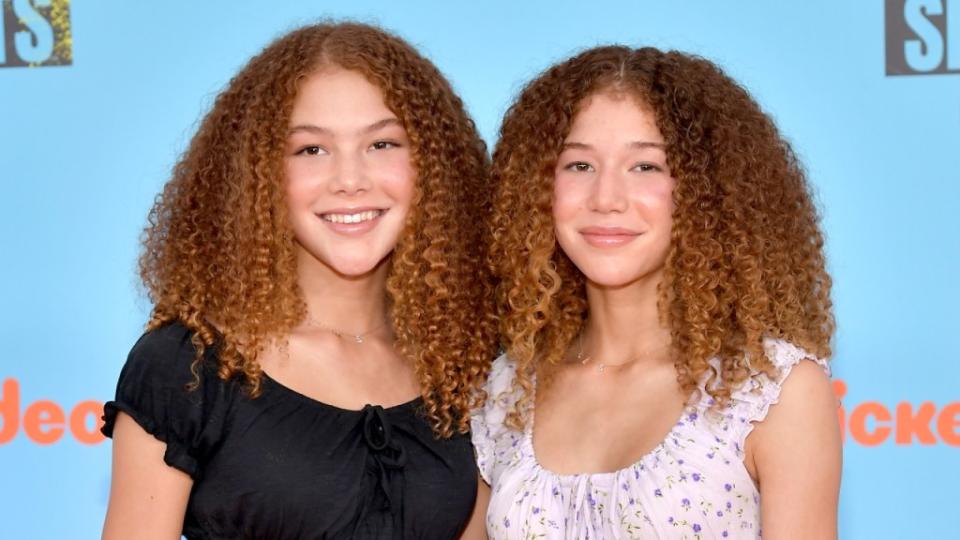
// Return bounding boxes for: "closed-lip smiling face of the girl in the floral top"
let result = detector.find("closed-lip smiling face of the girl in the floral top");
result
[553,92,675,287]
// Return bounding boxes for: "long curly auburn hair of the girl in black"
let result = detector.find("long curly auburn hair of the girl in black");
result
[140,23,496,437]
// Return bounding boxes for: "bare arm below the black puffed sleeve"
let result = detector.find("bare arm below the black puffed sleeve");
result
[103,413,193,540]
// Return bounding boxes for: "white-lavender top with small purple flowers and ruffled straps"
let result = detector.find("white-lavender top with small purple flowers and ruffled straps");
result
[472,339,829,540]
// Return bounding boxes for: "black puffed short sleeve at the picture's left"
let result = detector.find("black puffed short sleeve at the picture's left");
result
[102,323,235,480]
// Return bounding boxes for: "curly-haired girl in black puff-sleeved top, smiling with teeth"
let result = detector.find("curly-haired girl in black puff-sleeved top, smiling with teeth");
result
[103,24,494,539]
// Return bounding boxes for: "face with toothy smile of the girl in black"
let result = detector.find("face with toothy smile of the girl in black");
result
[284,67,416,277]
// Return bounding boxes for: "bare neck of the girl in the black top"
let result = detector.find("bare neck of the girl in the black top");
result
[297,249,390,334]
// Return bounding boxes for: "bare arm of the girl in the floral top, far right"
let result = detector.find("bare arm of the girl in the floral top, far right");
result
[745,361,842,540]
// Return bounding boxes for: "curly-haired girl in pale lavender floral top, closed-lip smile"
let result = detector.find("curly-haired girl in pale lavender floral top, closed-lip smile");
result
[473,47,841,539]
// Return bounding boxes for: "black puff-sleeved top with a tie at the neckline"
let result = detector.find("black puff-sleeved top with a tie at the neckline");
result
[103,324,477,540]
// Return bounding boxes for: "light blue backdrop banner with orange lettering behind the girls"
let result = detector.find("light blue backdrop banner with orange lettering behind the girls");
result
[0,0,960,539]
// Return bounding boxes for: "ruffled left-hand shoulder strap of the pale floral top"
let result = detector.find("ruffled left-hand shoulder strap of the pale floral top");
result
[470,354,519,485]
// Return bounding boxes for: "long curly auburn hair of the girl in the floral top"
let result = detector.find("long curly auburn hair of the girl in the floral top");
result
[488,46,834,425]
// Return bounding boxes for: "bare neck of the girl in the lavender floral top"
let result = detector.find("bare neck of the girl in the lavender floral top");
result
[582,272,670,365]
